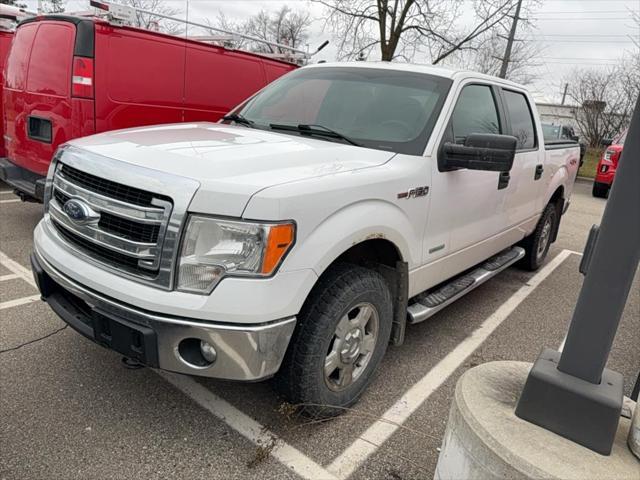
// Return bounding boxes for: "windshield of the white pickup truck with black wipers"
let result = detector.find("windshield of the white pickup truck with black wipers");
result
[233,67,451,155]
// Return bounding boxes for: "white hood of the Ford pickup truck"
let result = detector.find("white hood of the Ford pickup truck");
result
[69,123,394,216]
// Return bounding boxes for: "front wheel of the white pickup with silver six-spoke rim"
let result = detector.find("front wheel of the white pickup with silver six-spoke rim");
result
[274,264,393,418]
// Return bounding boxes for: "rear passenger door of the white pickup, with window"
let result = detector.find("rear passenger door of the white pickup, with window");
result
[501,88,544,228]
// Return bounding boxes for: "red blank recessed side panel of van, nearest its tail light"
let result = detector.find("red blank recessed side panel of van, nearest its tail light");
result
[103,33,185,106]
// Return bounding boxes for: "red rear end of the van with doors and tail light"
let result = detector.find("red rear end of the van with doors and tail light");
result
[3,16,95,186]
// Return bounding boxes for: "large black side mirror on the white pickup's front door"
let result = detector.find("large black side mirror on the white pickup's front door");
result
[440,133,518,172]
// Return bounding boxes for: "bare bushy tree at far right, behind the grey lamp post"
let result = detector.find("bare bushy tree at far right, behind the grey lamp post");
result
[568,53,640,147]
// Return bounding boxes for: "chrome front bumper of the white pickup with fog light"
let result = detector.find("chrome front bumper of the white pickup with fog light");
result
[31,252,296,381]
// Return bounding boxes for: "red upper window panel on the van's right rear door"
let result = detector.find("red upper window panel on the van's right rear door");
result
[27,22,76,97]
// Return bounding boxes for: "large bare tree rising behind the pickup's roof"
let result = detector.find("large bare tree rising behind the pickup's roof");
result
[312,0,516,64]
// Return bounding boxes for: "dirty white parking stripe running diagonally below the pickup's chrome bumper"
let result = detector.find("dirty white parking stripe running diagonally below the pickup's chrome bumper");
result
[156,370,337,480]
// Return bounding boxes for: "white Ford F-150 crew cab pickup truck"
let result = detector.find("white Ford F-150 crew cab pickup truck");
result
[32,62,580,415]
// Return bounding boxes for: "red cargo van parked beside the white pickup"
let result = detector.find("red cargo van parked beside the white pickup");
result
[0,15,296,201]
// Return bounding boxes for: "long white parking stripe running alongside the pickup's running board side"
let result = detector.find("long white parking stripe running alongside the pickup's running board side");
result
[327,250,577,479]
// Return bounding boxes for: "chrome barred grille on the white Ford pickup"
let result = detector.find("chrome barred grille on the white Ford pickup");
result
[49,163,173,278]
